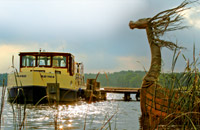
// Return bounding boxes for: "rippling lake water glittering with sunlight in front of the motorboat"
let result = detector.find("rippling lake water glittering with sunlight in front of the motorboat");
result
[0,88,141,130]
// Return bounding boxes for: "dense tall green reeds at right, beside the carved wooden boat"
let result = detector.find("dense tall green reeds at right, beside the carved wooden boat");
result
[160,46,200,130]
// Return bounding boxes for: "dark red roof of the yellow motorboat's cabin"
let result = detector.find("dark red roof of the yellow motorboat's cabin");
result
[19,52,73,56]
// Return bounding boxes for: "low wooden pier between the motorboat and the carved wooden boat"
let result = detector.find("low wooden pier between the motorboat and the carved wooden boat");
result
[101,87,140,101]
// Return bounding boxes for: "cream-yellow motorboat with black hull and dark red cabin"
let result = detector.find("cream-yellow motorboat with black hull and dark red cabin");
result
[7,50,84,103]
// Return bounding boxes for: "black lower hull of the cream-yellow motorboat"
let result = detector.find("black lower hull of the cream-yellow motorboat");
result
[8,86,78,104]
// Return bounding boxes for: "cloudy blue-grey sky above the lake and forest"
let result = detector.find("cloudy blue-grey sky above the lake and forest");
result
[0,0,200,73]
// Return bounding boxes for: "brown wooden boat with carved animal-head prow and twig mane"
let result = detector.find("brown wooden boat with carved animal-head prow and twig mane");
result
[129,1,200,130]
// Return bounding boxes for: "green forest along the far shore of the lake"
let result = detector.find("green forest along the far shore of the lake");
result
[0,70,196,88]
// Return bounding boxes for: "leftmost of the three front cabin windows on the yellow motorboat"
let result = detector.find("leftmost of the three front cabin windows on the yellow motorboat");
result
[22,55,36,67]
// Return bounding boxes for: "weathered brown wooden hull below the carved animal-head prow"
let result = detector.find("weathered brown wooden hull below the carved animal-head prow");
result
[140,81,181,130]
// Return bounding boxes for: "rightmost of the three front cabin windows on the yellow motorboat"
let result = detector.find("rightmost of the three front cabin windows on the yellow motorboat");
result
[53,56,66,67]
